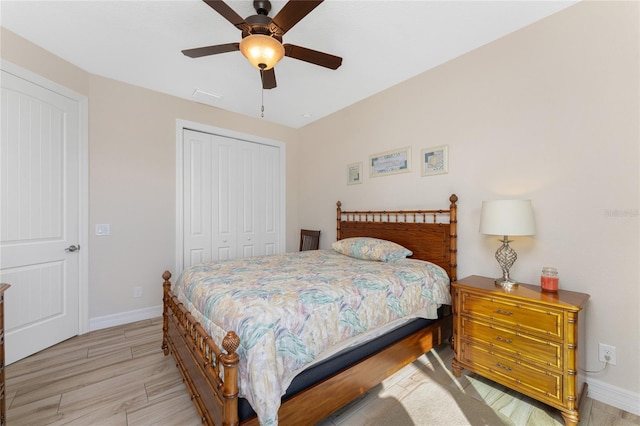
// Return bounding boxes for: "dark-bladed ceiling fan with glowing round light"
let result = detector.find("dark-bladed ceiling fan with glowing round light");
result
[182,0,342,89]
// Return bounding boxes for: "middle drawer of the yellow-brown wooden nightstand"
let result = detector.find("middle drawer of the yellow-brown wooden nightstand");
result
[461,317,562,368]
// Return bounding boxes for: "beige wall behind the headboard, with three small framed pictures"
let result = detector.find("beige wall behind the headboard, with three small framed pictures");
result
[297,2,640,398]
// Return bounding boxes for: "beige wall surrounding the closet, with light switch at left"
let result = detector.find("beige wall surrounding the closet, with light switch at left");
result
[89,76,296,317]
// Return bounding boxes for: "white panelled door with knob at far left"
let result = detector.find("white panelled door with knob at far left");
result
[0,70,80,363]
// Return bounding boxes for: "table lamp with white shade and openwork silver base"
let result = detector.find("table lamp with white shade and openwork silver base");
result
[480,200,536,288]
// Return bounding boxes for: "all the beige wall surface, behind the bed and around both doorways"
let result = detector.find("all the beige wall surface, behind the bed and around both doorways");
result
[2,2,640,410]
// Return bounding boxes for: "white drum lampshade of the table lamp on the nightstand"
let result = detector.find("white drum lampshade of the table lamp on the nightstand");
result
[480,200,536,236]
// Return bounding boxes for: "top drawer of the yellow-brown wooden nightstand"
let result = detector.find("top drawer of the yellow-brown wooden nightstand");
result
[460,291,564,339]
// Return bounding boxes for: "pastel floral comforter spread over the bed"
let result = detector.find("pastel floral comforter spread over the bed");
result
[174,250,451,425]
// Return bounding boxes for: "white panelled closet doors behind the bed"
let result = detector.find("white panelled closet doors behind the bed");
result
[183,129,281,267]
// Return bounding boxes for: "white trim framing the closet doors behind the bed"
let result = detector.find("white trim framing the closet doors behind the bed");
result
[174,119,287,276]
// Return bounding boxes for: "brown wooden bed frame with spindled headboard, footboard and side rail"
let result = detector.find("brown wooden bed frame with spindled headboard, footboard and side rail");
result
[162,194,458,425]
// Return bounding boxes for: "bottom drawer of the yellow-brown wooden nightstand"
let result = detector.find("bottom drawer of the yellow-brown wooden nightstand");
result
[461,341,562,403]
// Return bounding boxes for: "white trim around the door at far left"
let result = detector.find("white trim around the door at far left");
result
[0,59,89,334]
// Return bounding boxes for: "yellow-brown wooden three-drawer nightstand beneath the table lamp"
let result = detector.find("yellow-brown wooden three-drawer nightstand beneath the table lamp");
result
[452,275,589,424]
